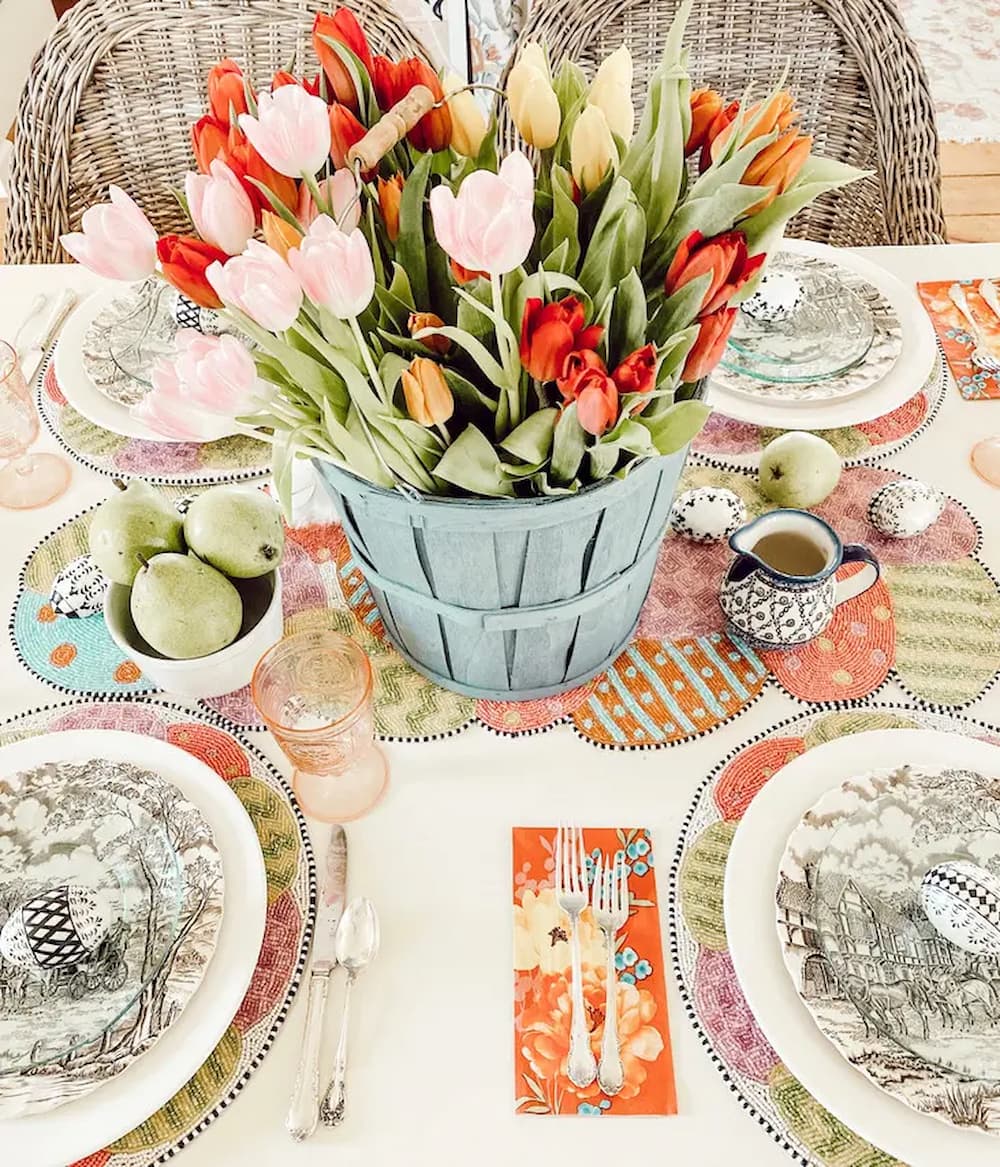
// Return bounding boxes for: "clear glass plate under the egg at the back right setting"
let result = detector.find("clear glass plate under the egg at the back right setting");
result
[721,252,875,384]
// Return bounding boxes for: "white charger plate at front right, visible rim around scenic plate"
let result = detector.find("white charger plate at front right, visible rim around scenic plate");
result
[723,729,1000,1167]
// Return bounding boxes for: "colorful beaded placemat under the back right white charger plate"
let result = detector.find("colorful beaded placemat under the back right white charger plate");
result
[691,357,947,470]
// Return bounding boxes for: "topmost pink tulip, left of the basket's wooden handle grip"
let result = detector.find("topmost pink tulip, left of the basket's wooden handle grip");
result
[239,85,330,179]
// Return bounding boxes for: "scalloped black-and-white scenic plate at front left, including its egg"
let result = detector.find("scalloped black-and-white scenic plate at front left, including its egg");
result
[0,747,223,1119]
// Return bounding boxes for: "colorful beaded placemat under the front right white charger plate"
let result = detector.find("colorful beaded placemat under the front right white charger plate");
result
[667,705,1000,1167]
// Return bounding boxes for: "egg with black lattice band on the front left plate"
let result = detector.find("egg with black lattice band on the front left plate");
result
[0,883,111,969]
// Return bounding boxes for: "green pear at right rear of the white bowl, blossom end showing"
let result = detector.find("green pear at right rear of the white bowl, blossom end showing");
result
[184,487,285,580]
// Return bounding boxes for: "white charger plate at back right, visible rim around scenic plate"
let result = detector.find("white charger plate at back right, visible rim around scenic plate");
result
[707,239,937,429]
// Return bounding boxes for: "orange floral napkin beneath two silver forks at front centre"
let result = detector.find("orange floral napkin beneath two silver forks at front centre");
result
[513,826,677,1114]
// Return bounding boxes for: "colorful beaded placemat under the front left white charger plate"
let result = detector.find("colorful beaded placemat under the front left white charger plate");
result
[0,696,316,1167]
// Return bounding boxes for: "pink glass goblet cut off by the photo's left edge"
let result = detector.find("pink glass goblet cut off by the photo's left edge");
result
[0,341,70,510]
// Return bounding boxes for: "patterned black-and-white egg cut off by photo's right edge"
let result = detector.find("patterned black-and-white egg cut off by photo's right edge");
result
[921,859,1000,956]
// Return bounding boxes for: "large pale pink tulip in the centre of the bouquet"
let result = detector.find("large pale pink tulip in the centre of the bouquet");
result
[431,151,534,275]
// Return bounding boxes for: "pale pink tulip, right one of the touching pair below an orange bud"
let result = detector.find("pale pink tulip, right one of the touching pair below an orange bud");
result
[288,215,375,320]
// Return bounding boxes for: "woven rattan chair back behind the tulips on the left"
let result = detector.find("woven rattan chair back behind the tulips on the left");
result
[6,0,426,264]
